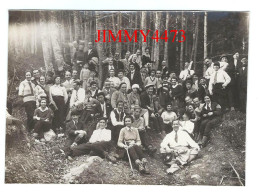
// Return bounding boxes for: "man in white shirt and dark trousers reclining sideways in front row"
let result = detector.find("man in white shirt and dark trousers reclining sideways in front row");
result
[71,118,116,162]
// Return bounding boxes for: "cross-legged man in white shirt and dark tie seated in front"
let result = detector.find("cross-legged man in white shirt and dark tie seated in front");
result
[160,120,200,174]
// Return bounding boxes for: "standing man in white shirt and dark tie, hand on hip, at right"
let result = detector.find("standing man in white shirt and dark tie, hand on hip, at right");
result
[209,62,231,110]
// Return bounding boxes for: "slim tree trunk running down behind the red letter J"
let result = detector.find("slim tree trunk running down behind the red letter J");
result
[95,11,105,87]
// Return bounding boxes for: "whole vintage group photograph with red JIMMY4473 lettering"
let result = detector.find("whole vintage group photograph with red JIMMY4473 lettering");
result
[5,10,249,186]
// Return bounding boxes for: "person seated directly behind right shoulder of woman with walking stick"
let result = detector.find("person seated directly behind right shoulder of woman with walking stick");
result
[132,105,157,154]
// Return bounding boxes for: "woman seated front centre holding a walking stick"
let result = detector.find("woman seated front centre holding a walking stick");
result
[117,116,149,174]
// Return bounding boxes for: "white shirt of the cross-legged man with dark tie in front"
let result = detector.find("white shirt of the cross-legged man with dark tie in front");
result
[160,128,200,151]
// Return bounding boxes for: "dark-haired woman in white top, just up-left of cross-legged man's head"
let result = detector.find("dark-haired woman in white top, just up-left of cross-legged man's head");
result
[161,103,177,134]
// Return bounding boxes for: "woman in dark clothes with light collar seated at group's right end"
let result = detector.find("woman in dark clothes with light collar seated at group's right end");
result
[199,96,221,147]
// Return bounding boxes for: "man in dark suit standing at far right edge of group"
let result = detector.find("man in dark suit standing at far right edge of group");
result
[237,58,248,112]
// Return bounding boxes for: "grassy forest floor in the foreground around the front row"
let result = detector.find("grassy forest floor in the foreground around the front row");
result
[5,103,246,185]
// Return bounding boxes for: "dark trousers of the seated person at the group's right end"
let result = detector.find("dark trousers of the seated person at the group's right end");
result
[200,117,221,137]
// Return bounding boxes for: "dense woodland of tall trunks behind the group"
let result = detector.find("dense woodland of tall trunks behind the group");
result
[9,10,249,80]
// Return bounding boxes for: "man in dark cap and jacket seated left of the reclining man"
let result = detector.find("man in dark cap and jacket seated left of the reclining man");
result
[63,111,86,156]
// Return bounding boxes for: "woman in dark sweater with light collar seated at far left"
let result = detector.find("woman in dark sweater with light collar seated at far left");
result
[33,98,54,142]
